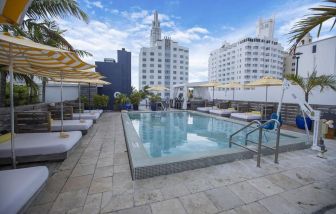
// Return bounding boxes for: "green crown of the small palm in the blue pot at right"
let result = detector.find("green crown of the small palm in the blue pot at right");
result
[286,71,336,103]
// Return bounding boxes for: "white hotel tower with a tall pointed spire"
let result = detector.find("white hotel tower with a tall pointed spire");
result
[139,11,189,98]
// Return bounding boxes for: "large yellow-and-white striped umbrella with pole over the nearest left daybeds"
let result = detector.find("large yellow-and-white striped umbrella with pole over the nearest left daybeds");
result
[0,34,95,168]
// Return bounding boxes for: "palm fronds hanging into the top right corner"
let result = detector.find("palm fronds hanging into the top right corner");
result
[289,0,336,50]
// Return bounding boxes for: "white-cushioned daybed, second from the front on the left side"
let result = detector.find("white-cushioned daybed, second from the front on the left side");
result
[0,131,82,164]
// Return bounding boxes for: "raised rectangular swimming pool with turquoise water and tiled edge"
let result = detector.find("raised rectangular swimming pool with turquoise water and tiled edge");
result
[122,111,306,179]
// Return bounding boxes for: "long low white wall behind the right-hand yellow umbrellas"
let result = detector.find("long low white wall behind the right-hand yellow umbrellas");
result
[210,86,336,105]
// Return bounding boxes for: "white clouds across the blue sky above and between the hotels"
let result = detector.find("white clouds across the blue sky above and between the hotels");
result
[59,1,332,87]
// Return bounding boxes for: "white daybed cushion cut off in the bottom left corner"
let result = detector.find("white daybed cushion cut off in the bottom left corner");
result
[0,166,49,214]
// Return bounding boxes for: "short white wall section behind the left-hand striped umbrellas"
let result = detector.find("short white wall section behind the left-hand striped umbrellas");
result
[46,83,78,103]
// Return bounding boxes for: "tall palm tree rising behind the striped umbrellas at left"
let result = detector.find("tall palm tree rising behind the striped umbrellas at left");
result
[0,0,90,107]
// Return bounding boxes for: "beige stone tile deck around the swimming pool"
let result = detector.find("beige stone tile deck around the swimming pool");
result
[28,113,336,214]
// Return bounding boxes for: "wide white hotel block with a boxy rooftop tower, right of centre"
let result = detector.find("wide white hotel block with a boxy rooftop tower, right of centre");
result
[208,19,284,84]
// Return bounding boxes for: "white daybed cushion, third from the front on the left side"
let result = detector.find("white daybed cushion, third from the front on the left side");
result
[51,119,93,132]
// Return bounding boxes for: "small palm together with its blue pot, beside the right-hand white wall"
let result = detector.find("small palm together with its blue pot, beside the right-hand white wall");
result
[286,71,336,129]
